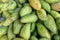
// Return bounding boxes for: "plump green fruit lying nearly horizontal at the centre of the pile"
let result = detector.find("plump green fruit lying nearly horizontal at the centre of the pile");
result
[20,14,38,23]
